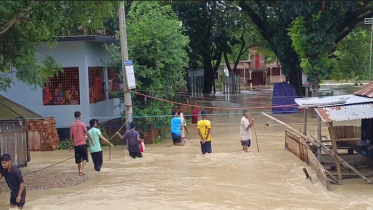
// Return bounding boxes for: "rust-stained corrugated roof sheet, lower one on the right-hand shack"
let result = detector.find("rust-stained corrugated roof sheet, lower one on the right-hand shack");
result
[315,104,373,122]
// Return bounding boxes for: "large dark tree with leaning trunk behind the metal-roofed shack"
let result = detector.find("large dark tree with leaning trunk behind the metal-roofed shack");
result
[239,0,373,95]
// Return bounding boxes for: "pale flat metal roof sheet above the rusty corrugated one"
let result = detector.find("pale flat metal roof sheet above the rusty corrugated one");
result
[294,94,373,108]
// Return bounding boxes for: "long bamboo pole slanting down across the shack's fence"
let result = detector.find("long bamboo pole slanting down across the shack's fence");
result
[262,112,372,184]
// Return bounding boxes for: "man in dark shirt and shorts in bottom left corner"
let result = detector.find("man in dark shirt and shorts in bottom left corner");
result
[0,154,26,209]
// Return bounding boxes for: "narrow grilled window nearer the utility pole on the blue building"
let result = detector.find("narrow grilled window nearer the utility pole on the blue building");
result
[88,67,105,104]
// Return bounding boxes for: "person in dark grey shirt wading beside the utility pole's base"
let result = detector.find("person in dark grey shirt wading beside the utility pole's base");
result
[117,122,144,159]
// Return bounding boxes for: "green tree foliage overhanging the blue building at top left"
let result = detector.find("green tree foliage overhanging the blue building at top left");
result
[0,1,112,90]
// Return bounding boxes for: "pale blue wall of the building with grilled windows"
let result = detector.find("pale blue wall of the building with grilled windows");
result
[0,41,121,128]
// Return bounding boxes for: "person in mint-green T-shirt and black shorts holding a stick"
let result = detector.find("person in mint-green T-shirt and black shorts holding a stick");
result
[88,119,113,171]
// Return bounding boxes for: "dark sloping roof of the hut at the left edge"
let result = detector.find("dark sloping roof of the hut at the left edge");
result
[0,95,41,120]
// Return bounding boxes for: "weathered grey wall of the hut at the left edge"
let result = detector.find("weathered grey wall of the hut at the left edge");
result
[0,120,30,166]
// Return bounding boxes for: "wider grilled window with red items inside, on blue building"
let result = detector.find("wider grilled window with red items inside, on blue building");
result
[43,67,80,106]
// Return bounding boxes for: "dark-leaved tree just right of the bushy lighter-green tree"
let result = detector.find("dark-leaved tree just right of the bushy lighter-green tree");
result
[173,1,227,93]
